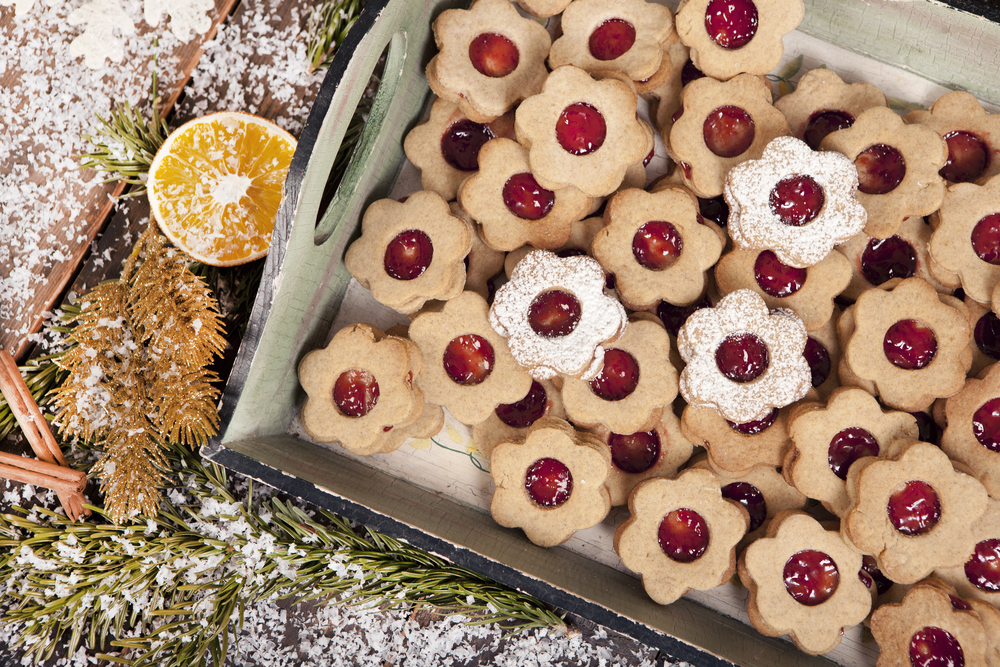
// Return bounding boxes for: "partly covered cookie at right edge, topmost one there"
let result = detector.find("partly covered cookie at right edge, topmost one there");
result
[903,90,1000,184]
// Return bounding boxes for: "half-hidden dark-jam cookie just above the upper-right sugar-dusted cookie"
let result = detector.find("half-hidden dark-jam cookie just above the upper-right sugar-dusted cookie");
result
[774,68,888,150]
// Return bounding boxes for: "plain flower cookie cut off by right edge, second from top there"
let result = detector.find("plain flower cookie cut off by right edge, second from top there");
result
[930,175,1000,304]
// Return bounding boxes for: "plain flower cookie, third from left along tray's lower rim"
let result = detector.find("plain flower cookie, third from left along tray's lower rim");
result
[615,469,749,604]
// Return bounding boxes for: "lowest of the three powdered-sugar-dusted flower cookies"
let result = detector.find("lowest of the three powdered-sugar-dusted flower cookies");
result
[677,290,812,423]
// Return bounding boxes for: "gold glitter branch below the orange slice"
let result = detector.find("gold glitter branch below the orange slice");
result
[55,224,226,523]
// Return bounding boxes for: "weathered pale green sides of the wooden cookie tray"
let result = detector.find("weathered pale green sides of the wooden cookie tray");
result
[203,0,1000,667]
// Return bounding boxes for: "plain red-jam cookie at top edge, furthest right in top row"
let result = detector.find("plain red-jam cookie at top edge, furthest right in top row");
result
[677,0,805,79]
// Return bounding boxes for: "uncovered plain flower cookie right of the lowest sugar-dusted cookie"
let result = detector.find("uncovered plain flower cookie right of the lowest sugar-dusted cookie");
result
[841,278,972,412]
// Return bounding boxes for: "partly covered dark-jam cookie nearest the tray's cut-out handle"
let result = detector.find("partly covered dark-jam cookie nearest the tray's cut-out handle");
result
[403,99,514,200]
